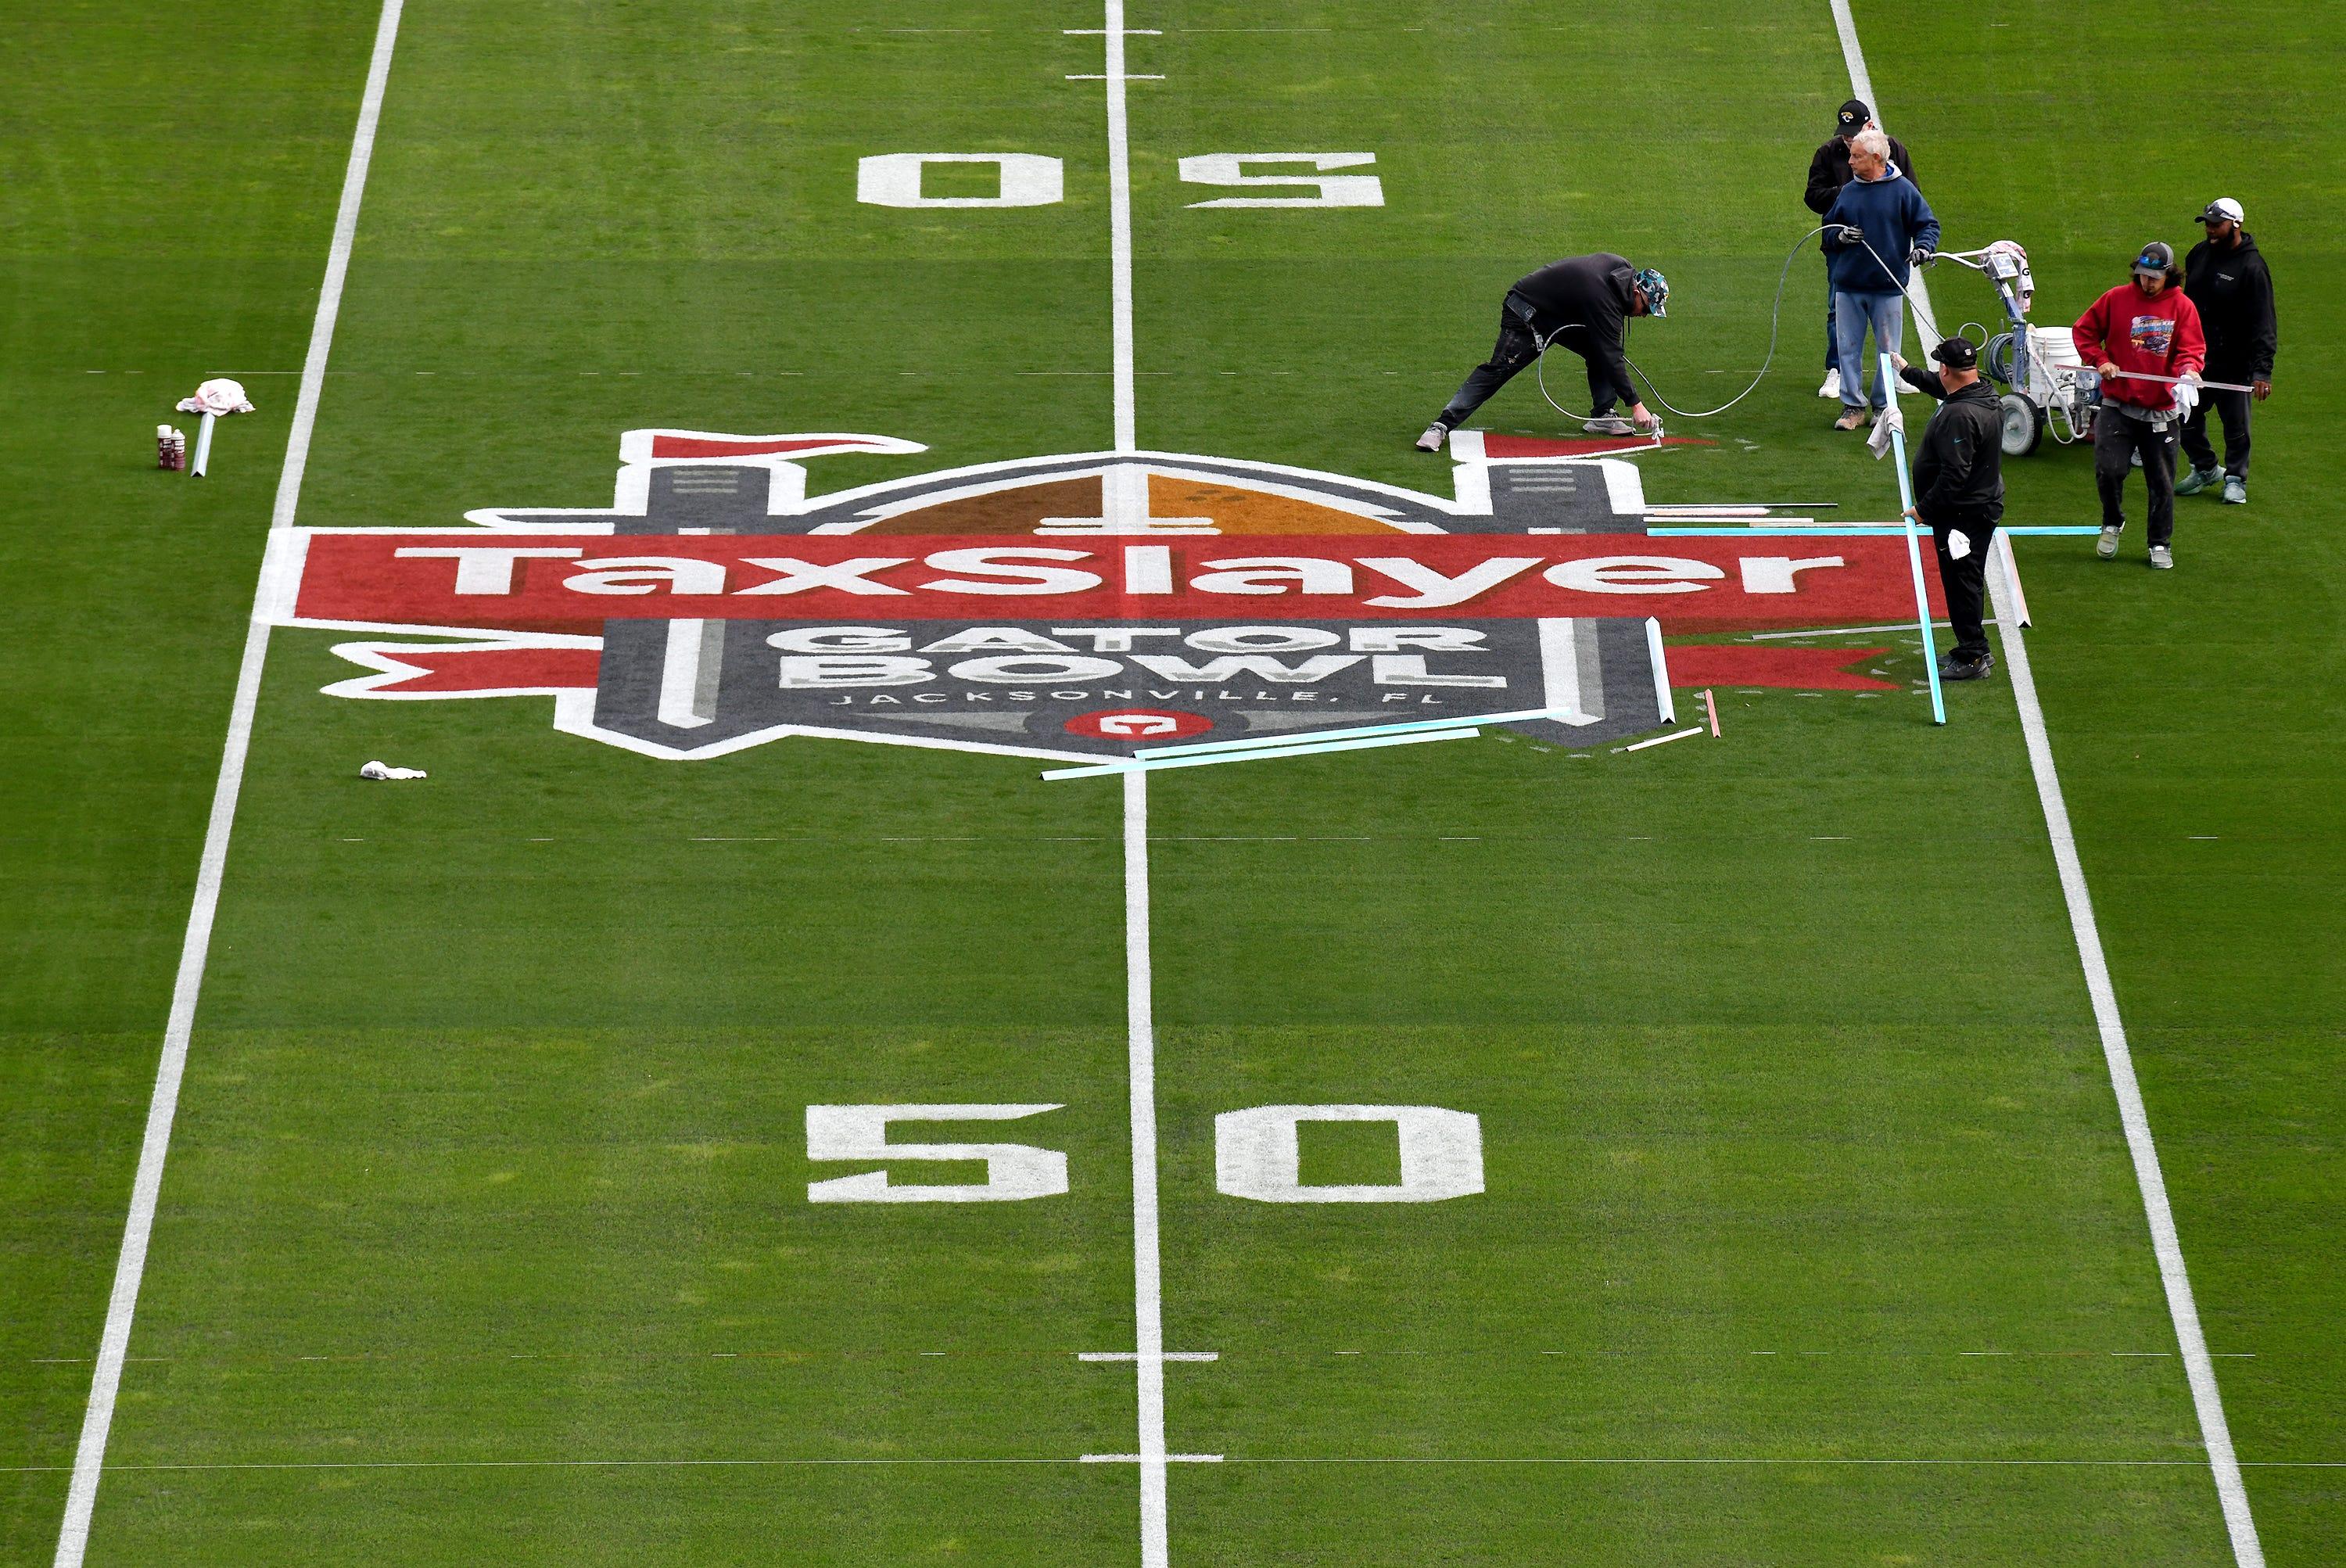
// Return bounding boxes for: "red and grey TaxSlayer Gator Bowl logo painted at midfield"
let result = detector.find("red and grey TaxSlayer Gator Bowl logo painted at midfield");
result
[270,429,1914,758]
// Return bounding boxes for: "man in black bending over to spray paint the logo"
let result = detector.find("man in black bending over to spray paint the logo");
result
[1417,251,1670,453]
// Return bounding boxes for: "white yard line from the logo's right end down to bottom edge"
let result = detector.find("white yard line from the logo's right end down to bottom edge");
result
[1987,556,2264,1568]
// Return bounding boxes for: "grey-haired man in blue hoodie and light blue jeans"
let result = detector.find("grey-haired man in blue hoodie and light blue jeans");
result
[1825,127,1938,429]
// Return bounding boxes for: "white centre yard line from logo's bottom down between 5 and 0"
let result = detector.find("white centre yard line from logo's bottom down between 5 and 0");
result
[1124,772,1168,1568]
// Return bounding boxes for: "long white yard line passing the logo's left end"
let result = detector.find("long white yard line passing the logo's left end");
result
[54,0,401,1568]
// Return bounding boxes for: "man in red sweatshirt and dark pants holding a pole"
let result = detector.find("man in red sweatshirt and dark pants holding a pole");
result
[2069,239,2208,570]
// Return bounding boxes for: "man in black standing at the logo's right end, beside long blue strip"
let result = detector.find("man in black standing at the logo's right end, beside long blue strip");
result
[1898,338,2003,680]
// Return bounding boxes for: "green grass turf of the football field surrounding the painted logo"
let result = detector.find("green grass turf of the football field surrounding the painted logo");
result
[0,0,2346,1568]
